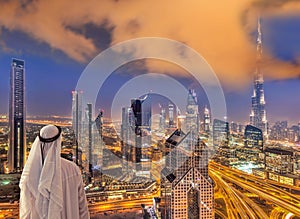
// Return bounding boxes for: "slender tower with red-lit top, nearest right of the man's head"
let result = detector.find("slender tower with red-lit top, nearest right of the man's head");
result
[72,91,83,147]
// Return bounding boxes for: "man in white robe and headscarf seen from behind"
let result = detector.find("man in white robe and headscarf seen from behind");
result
[20,125,90,219]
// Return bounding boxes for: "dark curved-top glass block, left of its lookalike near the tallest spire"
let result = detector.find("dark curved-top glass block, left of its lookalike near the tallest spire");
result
[213,119,229,146]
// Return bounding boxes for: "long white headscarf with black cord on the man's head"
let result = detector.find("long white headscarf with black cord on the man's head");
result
[20,125,63,219]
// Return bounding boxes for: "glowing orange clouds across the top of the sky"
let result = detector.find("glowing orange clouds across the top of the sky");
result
[0,0,300,89]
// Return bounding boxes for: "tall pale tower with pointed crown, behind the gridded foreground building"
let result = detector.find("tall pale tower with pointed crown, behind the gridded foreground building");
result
[185,90,200,139]
